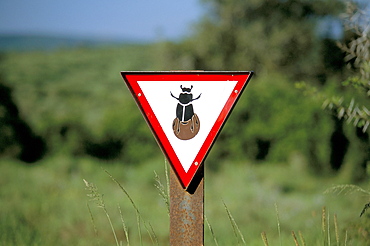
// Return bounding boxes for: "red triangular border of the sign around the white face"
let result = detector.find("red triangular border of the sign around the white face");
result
[121,71,253,188]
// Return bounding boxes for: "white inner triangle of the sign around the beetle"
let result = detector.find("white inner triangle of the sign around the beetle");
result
[137,80,238,172]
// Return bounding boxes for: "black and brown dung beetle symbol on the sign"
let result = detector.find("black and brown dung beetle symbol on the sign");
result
[170,85,202,140]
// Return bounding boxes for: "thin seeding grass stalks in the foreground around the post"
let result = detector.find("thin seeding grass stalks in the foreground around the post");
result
[84,163,369,246]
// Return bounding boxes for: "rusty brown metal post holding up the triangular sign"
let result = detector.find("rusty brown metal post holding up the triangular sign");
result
[170,162,204,246]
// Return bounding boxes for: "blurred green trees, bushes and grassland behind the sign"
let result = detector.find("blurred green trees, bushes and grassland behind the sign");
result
[0,0,370,245]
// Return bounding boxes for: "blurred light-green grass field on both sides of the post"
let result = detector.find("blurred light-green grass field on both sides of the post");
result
[0,156,370,246]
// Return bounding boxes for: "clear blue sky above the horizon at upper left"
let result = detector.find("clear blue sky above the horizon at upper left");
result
[0,0,204,40]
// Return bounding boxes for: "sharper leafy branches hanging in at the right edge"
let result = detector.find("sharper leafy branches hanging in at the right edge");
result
[323,3,370,132]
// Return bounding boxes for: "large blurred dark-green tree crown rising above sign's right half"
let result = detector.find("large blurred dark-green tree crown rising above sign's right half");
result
[182,0,342,79]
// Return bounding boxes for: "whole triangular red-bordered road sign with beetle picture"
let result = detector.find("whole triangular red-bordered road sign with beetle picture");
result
[121,71,253,188]
